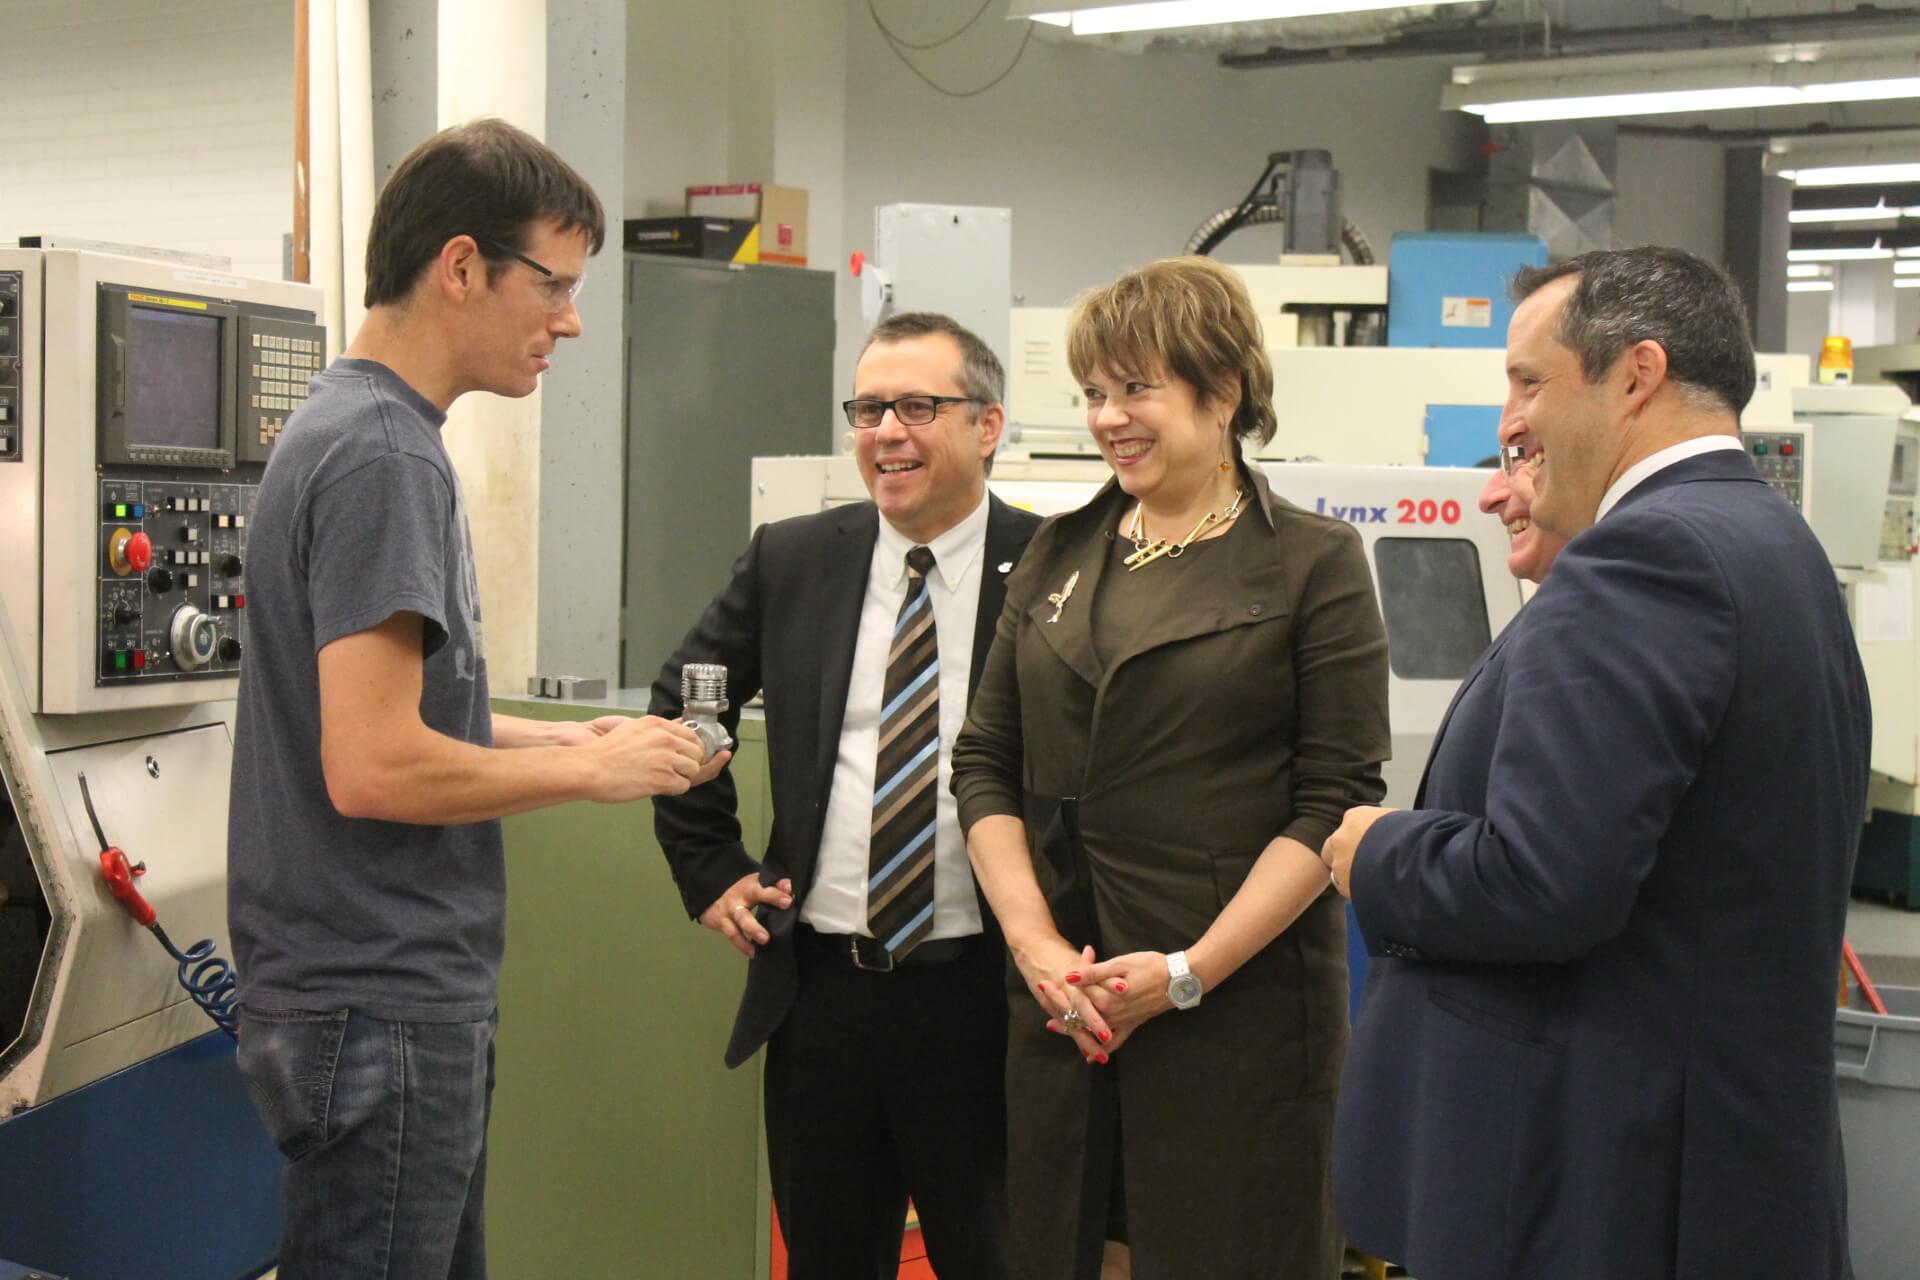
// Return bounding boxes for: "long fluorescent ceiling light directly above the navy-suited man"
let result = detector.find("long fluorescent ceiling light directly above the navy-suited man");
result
[1440,38,1920,125]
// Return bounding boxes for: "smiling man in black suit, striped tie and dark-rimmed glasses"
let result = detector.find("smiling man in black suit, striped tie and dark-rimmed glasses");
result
[651,313,1039,1280]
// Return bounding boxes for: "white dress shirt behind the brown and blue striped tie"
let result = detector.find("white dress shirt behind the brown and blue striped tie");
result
[801,495,996,938]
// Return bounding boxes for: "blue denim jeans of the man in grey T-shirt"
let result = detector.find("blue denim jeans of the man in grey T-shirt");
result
[240,1006,497,1280]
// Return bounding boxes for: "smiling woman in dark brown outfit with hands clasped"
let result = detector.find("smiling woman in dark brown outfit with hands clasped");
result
[952,257,1388,1280]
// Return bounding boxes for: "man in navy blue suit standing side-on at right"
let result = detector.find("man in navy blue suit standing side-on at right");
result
[1325,249,1870,1280]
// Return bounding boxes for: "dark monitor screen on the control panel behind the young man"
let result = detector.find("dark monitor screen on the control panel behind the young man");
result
[127,305,221,449]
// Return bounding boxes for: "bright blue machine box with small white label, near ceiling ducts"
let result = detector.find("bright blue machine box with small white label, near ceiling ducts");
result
[1386,232,1548,347]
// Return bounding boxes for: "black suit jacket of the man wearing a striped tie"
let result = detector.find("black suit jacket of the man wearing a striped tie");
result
[649,497,1041,1067]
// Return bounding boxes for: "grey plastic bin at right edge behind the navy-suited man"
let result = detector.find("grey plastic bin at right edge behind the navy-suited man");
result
[1834,986,1920,1280]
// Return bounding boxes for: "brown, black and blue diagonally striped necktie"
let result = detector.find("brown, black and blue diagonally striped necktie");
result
[866,547,941,958]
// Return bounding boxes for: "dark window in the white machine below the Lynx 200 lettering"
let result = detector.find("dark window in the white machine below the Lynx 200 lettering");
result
[1373,537,1494,679]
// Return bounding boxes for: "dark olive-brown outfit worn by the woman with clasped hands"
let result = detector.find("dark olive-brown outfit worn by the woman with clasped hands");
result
[952,472,1388,1280]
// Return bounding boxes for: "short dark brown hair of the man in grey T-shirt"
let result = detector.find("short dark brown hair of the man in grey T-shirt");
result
[365,119,607,307]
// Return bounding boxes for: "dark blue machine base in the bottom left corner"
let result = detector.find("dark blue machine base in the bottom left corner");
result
[0,1031,280,1280]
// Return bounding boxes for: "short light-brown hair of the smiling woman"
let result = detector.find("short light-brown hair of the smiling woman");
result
[1068,257,1275,445]
